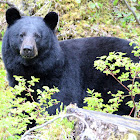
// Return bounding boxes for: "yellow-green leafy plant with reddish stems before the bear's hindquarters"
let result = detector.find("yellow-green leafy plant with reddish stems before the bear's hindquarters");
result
[85,43,140,117]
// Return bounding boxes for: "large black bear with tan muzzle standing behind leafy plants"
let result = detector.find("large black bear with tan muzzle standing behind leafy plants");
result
[2,8,138,115]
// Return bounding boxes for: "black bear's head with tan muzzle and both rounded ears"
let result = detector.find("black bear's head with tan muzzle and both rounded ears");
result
[6,8,58,60]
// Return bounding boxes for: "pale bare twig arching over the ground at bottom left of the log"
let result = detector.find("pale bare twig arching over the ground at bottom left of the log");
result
[21,114,93,140]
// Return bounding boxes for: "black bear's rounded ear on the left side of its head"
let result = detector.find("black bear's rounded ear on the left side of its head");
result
[6,8,21,25]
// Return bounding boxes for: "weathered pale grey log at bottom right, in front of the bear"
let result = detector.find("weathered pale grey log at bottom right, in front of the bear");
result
[67,108,140,140]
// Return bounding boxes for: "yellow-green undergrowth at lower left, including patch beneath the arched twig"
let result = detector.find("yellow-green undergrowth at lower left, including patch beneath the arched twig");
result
[0,73,74,140]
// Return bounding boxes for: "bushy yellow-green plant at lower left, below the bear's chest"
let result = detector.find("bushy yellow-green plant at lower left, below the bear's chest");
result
[0,76,59,139]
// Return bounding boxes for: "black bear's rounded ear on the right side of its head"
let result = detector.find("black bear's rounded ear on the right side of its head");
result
[44,12,58,30]
